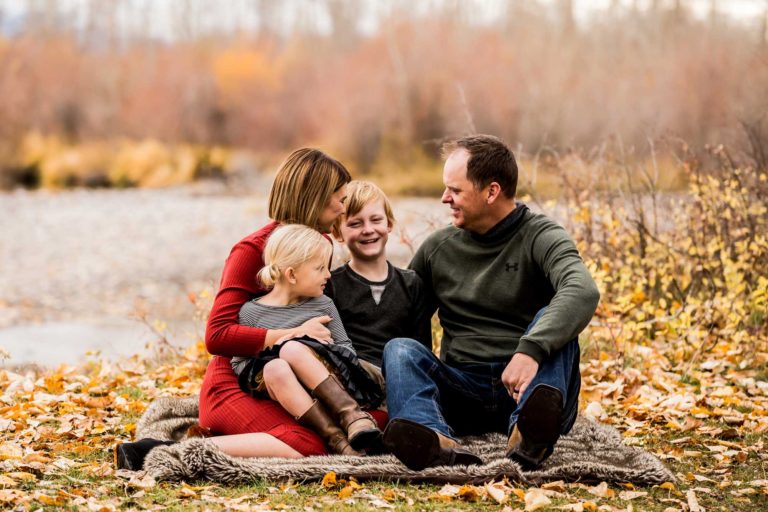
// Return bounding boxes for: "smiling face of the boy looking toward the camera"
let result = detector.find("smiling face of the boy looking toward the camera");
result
[341,201,392,261]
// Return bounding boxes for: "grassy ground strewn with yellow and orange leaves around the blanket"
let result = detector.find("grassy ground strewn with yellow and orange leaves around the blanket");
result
[0,334,768,511]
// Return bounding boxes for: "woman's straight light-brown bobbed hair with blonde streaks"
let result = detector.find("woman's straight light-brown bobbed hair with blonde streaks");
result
[269,148,352,228]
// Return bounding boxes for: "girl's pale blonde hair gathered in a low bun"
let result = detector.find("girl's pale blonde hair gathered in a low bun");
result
[257,224,333,288]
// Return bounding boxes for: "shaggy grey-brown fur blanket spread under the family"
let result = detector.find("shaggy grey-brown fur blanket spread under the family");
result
[136,397,675,484]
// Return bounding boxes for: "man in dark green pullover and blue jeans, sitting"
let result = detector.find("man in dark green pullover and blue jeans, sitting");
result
[383,135,599,470]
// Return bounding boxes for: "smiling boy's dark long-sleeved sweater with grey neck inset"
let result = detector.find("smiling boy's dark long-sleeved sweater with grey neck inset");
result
[325,262,432,366]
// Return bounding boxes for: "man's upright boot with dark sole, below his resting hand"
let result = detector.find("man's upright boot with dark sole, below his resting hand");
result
[507,384,563,470]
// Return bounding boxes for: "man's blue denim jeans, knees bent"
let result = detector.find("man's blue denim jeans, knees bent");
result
[382,312,581,437]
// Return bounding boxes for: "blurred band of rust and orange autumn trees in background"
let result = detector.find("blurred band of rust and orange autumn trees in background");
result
[0,0,768,188]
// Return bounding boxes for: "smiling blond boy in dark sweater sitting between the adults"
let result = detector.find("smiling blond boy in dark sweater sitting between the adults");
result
[325,181,432,376]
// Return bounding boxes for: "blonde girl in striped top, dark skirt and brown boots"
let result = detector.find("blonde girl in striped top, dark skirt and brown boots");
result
[232,224,381,455]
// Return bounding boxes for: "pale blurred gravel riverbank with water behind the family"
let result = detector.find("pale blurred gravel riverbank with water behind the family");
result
[0,182,447,365]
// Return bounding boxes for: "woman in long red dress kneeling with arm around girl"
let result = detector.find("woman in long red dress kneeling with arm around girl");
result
[115,148,386,469]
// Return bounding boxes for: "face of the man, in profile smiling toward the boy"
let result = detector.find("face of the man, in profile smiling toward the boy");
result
[441,148,488,231]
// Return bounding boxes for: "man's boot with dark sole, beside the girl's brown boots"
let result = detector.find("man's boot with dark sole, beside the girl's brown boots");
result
[384,418,483,471]
